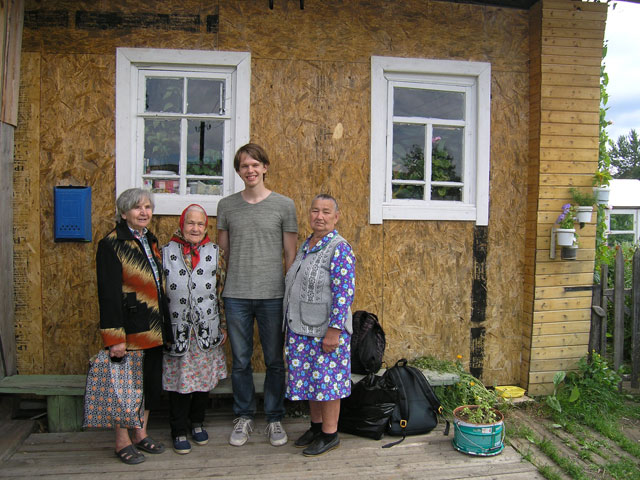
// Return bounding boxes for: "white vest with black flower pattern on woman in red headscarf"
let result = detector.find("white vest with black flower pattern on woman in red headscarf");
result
[162,242,220,356]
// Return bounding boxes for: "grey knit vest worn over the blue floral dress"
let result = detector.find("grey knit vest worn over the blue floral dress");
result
[283,234,353,337]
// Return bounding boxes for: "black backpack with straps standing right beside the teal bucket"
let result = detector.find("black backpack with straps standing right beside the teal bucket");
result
[383,358,449,448]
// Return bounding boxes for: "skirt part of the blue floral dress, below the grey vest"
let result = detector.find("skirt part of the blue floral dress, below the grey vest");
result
[285,330,351,402]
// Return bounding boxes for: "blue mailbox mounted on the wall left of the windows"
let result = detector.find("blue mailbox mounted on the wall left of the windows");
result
[53,186,91,242]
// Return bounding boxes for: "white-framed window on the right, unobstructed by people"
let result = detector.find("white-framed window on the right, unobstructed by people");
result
[369,57,491,225]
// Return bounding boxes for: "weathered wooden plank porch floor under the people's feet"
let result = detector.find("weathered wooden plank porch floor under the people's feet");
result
[0,406,543,480]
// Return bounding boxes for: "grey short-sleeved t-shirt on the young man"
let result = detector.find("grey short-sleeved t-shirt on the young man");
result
[218,192,298,300]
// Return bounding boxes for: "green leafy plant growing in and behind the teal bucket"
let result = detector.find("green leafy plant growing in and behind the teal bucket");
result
[411,356,501,423]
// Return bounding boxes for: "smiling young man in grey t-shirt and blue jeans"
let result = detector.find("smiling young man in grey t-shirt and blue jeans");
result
[218,143,298,447]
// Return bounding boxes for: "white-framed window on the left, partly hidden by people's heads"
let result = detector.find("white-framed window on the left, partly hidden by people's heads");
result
[116,48,251,215]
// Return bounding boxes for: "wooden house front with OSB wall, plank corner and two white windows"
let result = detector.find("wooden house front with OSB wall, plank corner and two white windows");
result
[0,0,607,394]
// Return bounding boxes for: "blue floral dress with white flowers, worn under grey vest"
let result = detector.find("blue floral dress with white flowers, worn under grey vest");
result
[285,230,356,401]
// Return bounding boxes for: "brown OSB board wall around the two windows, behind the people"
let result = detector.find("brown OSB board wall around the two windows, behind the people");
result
[16,0,528,383]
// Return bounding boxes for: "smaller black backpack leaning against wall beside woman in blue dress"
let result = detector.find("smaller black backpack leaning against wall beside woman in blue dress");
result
[351,310,386,375]
